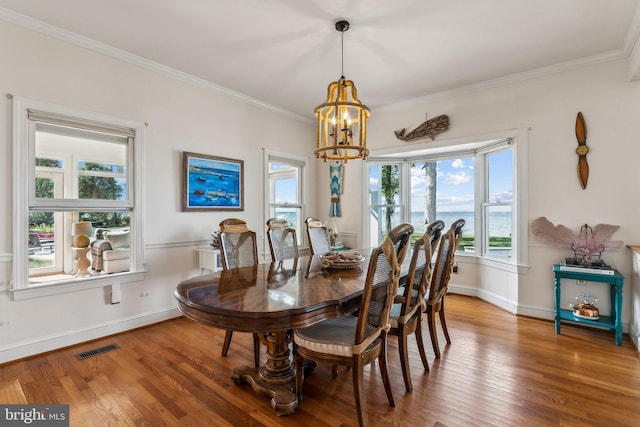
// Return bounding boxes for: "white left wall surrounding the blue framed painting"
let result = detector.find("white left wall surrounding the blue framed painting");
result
[0,22,317,363]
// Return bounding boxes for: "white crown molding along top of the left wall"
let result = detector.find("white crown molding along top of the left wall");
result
[0,7,313,123]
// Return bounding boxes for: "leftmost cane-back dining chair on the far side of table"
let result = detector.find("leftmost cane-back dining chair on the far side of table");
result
[219,218,260,368]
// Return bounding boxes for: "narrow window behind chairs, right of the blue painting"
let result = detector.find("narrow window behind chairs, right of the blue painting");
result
[265,153,306,252]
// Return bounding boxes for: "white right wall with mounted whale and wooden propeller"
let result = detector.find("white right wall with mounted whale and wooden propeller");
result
[330,60,640,330]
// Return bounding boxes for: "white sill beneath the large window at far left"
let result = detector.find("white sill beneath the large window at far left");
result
[11,270,147,301]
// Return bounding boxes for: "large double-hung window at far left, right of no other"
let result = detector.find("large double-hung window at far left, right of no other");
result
[13,98,142,299]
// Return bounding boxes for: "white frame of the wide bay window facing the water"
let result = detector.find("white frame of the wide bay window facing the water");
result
[361,129,528,272]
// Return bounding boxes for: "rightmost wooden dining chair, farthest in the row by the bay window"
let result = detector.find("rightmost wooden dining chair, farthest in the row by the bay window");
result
[425,229,457,359]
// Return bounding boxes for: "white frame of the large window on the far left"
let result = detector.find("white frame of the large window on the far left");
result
[11,97,146,300]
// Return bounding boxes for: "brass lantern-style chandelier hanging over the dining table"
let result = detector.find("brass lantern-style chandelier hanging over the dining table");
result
[314,21,371,163]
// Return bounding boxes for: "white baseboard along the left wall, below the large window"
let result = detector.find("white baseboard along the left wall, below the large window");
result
[0,307,181,364]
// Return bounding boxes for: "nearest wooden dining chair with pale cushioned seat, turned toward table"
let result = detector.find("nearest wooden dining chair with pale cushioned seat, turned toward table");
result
[293,224,413,426]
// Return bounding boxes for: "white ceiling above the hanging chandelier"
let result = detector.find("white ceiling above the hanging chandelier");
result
[0,0,640,118]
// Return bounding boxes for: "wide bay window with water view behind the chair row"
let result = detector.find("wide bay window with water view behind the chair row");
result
[366,131,527,263]
